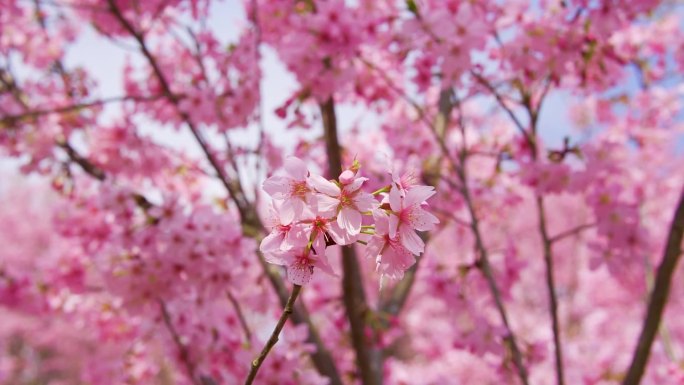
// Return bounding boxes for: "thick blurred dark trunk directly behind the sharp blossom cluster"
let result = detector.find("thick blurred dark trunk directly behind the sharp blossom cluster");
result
[320,97,382,385]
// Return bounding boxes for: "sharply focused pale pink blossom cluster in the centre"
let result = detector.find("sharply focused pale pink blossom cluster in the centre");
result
[260,157,439,285]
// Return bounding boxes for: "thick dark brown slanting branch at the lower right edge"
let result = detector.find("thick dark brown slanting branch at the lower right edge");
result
[622,190,684,385]
